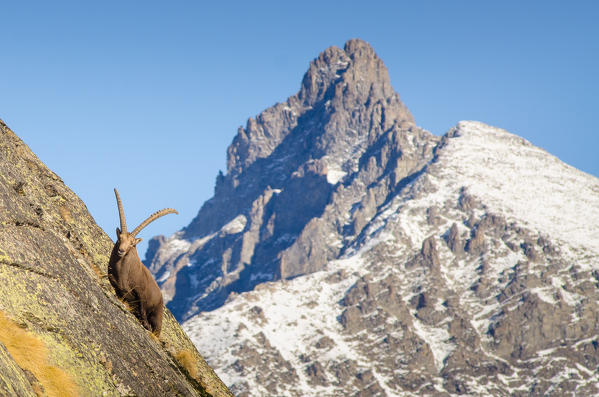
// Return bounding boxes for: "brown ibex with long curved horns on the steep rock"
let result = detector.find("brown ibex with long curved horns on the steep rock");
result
[108,189,178,336]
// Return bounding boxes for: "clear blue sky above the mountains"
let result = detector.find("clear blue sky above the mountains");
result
[0,0,599,256]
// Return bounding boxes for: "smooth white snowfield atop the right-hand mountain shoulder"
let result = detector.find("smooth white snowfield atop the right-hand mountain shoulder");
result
[438,122,599,252]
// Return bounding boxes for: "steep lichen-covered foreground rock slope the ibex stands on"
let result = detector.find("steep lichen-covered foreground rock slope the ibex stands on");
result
[0,121,230,396]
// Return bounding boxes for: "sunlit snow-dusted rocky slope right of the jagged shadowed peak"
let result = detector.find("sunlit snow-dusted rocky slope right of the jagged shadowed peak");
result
[184,122,599,396]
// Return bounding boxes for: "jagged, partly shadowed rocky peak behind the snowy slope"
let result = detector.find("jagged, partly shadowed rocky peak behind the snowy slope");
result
[145,40,438,319]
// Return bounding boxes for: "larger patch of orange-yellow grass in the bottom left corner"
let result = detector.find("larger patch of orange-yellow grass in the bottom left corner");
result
[0,311,78,397]
